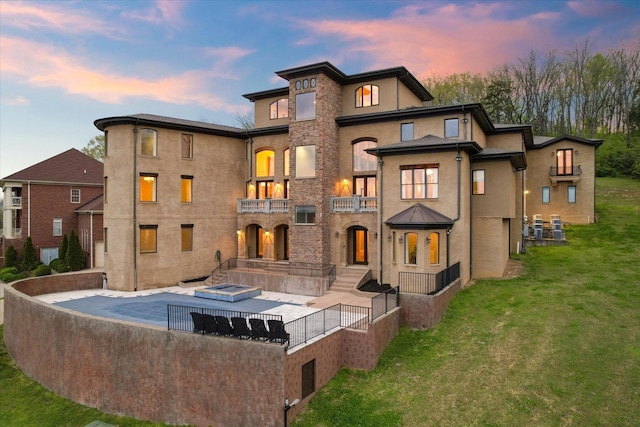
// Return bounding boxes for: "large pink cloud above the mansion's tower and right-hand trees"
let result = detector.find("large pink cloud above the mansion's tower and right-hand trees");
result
[300,3,559,78]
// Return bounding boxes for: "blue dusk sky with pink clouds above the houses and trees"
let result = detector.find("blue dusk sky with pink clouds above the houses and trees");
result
[0,0,640,177]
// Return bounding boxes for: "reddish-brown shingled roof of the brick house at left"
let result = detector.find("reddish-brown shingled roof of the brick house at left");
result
[2,148,104,185]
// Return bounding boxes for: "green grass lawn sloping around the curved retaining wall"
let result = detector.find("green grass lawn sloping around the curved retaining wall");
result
[0,179,640,427]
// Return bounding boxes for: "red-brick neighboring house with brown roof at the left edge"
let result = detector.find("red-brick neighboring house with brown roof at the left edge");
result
[0,149,103,267]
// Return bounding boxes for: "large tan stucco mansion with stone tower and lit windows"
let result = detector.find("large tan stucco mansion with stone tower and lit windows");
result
[95,62,599,295]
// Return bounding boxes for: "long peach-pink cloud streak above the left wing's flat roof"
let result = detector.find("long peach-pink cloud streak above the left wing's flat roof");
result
[0,37,250,112]
